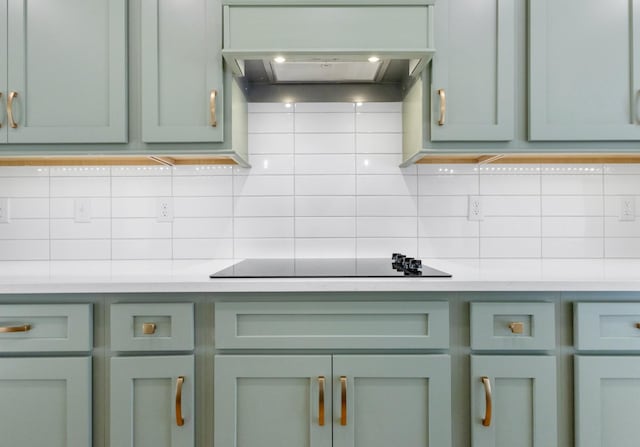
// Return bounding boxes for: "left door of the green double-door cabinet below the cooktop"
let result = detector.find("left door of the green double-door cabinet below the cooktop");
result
[214,355,332,447]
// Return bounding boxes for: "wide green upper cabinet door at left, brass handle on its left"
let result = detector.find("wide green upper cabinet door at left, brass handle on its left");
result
[6,0,127,143]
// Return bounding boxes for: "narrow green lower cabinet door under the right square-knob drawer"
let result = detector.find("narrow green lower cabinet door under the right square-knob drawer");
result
[471,355,558,447]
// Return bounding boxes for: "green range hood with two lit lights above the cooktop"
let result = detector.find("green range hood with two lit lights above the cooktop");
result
[222,0,434,102]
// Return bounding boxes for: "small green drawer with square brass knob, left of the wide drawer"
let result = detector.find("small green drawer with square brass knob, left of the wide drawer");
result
[111,303,194,351]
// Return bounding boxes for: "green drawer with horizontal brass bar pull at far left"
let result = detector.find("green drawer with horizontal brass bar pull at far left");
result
[0,304,93,352]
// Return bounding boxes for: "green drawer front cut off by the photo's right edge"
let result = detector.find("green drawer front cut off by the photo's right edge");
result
[573,303,640,351]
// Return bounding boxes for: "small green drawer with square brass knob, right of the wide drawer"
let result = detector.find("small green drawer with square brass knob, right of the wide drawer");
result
[471,303,556,350]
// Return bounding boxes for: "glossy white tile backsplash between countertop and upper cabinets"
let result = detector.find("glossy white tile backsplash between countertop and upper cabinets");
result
[0,103,640,260]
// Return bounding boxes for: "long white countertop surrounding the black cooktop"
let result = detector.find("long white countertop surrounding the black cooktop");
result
[0,259,640,294]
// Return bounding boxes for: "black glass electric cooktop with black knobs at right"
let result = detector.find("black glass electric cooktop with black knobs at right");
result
[210,253,451,278]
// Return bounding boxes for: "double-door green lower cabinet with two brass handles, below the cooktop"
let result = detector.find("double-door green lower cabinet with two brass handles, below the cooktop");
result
[214,355,451,447]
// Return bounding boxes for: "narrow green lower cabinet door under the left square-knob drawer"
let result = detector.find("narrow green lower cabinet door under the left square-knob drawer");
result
[110,355,195,447]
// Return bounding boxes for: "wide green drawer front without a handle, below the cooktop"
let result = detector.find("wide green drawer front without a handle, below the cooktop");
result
[215,302,449,349]
